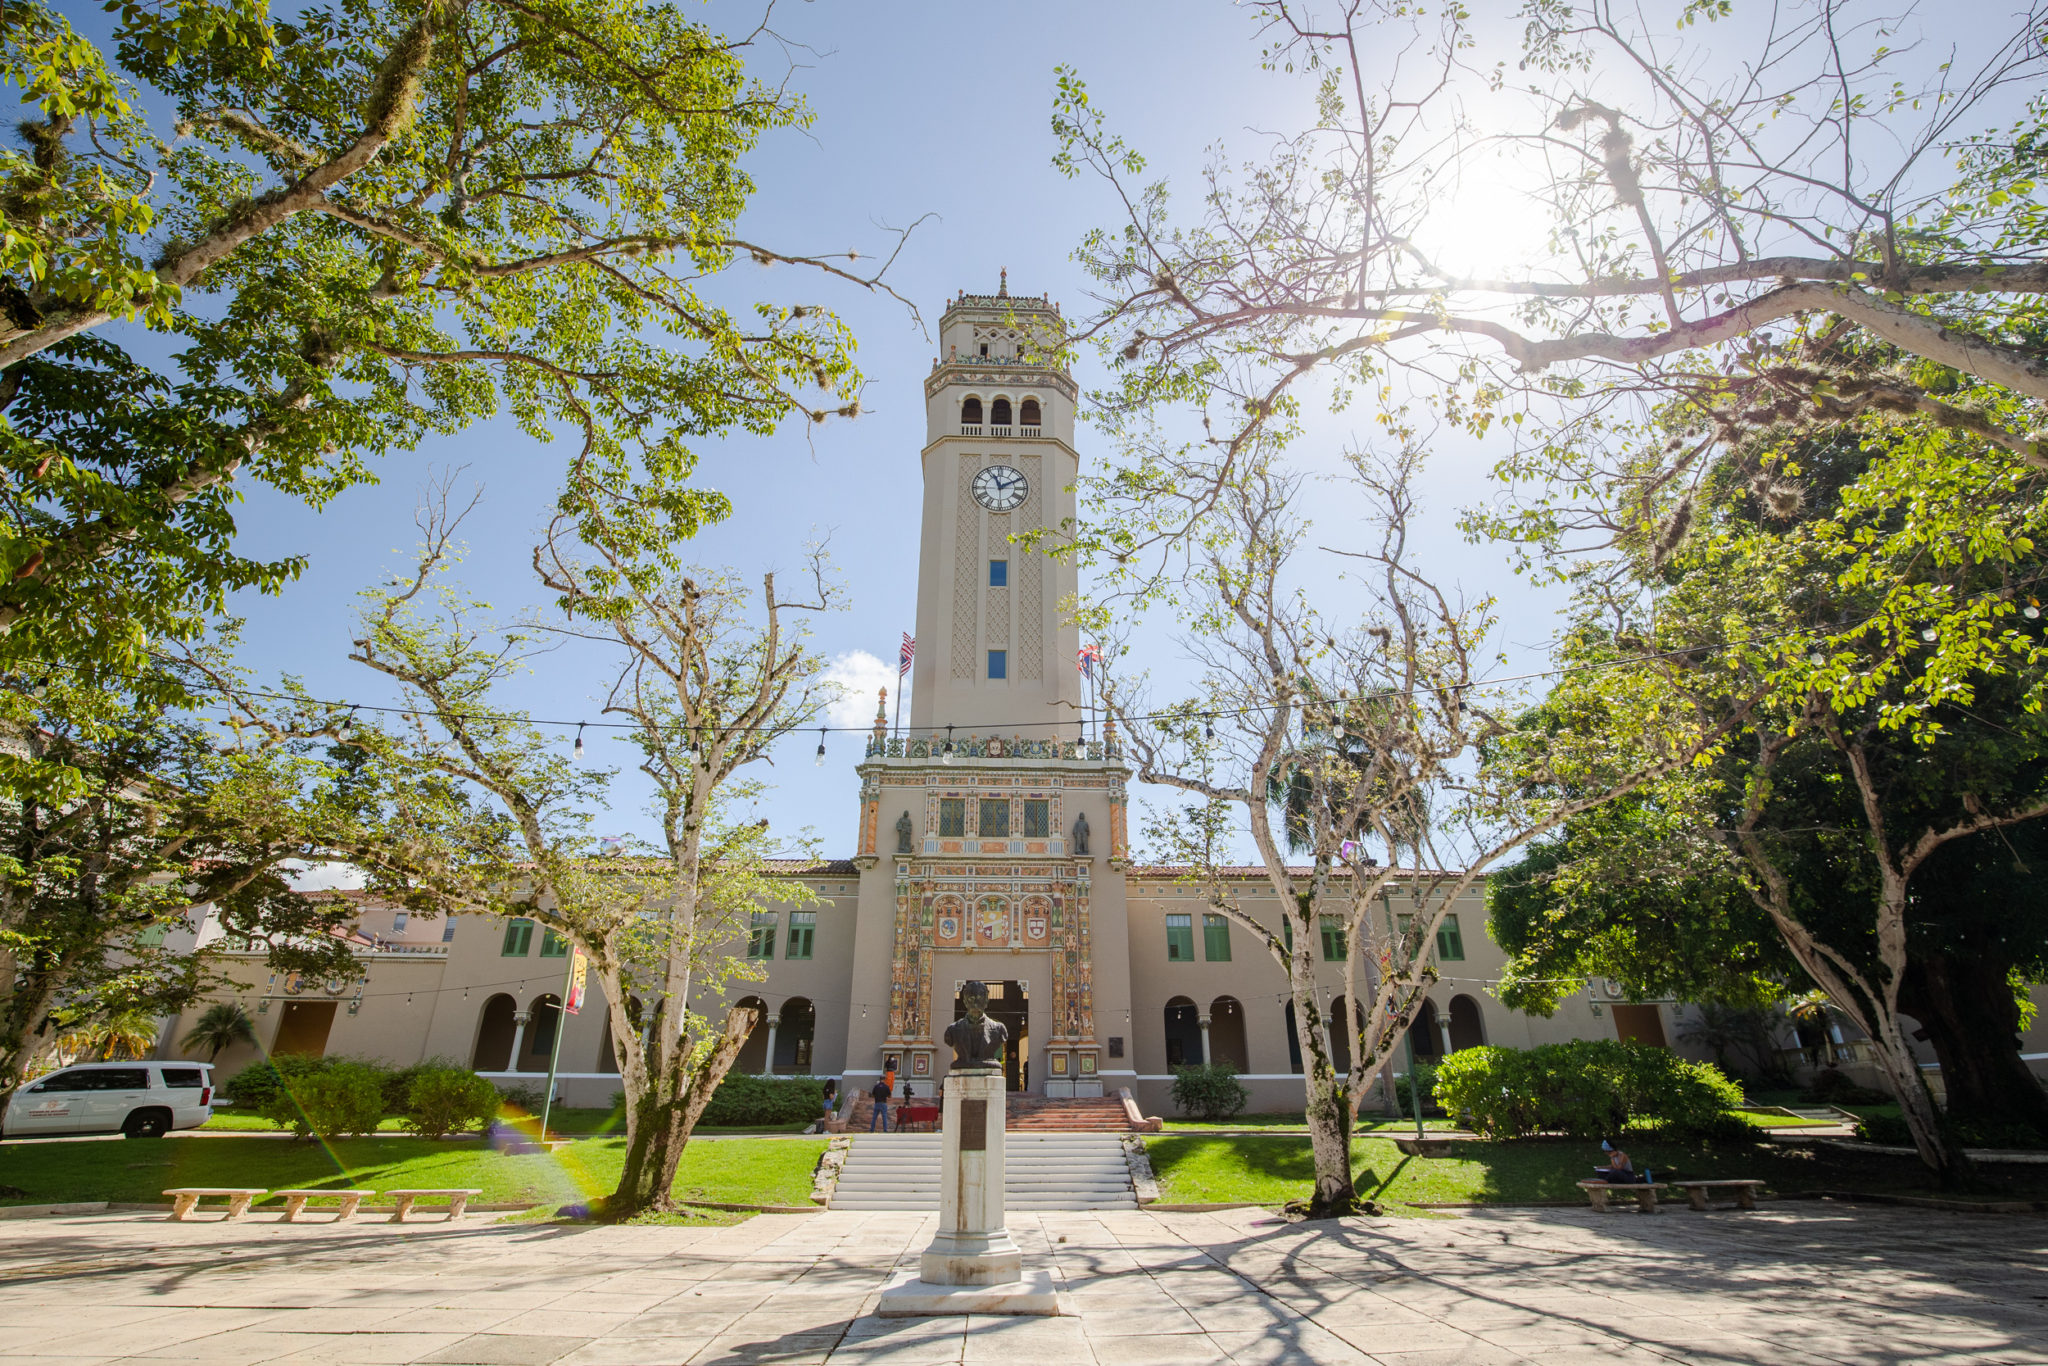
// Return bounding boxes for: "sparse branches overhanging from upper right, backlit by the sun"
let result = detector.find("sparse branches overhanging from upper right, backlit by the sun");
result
[1053,0,2048,573]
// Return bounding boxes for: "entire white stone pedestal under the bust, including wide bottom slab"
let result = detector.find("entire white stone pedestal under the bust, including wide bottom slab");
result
[877,1069,1059,1317]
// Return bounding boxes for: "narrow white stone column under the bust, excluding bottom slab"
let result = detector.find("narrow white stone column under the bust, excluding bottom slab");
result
[918,1069,1024,1286]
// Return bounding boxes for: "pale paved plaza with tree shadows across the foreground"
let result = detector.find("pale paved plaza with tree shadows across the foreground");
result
[0,1202,2048,1366]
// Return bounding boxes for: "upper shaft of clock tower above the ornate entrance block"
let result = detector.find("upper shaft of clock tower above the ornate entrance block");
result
[909,272,1081,741]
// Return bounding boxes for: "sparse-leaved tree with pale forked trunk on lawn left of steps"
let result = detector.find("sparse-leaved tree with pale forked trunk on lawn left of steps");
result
[256,489,840,1219]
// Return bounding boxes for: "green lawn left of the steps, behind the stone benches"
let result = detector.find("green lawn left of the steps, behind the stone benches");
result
[0,1139,825,1206]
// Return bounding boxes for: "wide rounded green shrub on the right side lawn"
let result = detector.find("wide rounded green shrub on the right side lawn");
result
[1436,1038,1743,1139]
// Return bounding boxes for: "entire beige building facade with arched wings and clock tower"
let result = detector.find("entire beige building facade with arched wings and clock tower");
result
[168,283,2023,1112]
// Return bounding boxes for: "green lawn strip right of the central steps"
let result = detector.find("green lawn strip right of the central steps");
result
[1145,1135,2048,1214]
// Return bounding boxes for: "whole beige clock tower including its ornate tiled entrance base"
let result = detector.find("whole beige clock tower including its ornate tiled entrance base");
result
[846,276,1137,1098]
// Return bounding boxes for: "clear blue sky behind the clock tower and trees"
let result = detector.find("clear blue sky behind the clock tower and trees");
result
[211,0,1552,854]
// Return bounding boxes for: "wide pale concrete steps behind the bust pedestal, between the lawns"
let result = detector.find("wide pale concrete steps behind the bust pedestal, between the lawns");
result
[831,1130,1137,1212]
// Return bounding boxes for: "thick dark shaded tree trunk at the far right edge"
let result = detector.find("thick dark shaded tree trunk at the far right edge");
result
[1898,952,2048,1137]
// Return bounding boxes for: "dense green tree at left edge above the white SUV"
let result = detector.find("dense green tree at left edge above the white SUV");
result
[0,666,360,1104]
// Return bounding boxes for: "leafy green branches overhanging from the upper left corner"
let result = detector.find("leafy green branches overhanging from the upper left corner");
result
[0,0,901,676]
